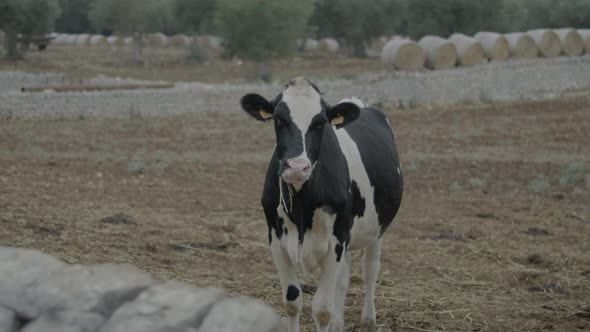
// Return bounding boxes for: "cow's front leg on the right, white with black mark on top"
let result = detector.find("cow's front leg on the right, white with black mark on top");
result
[311,244,346,332]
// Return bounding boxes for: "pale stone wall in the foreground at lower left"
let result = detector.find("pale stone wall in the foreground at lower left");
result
[0,247,283,332]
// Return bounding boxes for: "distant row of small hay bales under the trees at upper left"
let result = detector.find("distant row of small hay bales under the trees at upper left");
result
[52,33,221,50]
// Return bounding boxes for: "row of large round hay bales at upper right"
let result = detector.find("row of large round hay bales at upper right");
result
[381,28,590,70]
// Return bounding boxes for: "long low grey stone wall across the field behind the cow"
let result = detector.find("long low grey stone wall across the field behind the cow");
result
[0,55,590,118]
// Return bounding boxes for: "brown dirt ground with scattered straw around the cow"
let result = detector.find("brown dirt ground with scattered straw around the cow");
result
[0,98,590,331]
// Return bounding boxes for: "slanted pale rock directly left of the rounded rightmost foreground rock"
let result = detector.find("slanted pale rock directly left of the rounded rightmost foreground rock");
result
[99,282,224,332]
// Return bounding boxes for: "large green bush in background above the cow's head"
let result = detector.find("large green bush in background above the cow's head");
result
[215,0,313,60]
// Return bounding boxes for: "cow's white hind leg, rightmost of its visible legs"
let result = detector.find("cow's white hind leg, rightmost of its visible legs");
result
[361,238,382,332]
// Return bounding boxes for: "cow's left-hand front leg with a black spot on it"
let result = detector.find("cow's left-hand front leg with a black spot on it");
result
[270,232,303,332]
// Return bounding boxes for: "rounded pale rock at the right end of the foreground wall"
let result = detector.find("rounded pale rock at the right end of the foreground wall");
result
[199,297,285,332]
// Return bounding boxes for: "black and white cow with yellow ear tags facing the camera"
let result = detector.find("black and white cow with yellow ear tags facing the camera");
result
[241,77,403,331]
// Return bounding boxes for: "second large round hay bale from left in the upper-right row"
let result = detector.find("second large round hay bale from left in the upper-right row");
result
[418,36,457,70]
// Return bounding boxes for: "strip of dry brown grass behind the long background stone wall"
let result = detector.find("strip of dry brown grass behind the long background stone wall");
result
[0,45,384,83]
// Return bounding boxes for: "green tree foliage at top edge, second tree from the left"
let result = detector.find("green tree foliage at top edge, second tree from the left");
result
[89,0,174,34]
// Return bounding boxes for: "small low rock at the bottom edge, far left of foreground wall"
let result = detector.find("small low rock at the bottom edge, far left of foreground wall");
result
[21,311,104,332]
